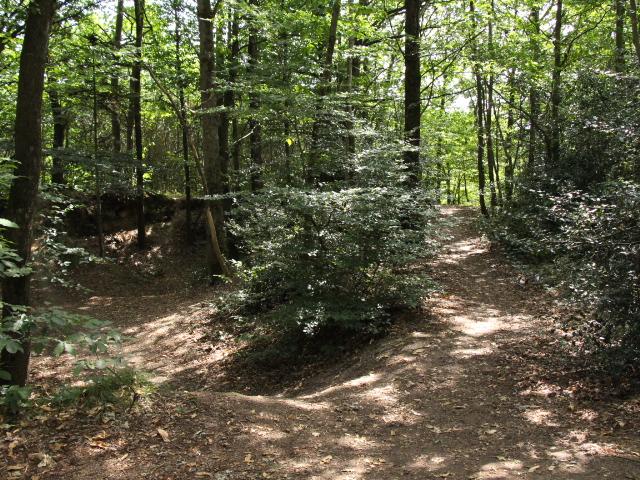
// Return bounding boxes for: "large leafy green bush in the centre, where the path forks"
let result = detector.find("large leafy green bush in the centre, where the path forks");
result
[221,148,434,335]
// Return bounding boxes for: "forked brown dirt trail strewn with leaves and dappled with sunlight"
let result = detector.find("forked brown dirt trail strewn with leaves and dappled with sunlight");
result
[17,208,640,480]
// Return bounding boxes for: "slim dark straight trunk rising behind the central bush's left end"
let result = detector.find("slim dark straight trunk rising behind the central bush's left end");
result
[248,0,263,192]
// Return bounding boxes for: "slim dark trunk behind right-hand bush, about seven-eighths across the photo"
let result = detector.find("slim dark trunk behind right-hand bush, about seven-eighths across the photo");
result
[547,0,564,172]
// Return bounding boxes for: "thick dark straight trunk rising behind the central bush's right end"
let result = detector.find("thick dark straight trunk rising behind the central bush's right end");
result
[404,0,421,186]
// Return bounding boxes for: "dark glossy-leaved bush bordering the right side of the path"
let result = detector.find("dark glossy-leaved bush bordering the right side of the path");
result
[492,181,640,362]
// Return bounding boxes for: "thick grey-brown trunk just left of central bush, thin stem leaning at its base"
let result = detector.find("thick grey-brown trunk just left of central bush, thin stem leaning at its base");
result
[198,0,228,275]
